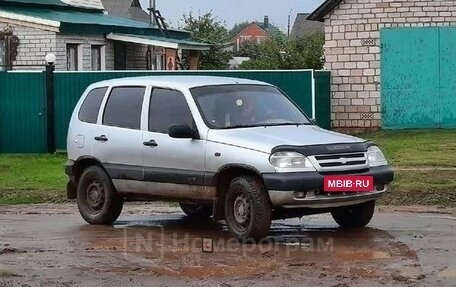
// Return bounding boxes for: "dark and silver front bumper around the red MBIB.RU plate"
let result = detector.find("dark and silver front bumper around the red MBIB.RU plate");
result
[263,166,394,208]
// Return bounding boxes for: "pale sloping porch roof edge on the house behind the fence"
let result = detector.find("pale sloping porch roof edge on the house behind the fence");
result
[106,33,210,51]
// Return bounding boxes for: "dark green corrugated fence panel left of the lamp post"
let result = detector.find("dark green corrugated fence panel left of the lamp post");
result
[0,72,46,153]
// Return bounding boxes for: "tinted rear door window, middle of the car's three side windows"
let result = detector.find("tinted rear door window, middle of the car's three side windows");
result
[103,87,146,130]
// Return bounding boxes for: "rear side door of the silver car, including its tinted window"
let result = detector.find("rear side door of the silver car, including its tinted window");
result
[93,86,146,182]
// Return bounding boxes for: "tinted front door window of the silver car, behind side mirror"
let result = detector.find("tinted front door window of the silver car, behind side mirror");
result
[149,88,194,134]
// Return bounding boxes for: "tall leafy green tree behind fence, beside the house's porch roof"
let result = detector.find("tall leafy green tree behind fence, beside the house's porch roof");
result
[183,12,231,70]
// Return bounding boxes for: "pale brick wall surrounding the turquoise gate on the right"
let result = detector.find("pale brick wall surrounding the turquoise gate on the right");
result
[325,0,456,129]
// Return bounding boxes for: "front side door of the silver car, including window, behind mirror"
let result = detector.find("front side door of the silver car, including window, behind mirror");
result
[143,88,206,192]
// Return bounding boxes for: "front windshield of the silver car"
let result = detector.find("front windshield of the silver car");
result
[191,85,311,129]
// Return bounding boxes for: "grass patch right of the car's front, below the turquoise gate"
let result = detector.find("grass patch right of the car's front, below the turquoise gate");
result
[361,130,456,207]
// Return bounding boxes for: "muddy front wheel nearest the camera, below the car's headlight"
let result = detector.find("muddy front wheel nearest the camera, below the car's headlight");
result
[225,176,272,242]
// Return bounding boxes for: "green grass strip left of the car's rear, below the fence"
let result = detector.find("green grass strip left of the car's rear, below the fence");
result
[0,155,67,204]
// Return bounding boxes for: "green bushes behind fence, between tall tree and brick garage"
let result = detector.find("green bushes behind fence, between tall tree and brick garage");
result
[241,33,325,70]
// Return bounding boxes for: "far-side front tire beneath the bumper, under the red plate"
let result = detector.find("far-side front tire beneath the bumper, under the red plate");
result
[331,201,375,228]
